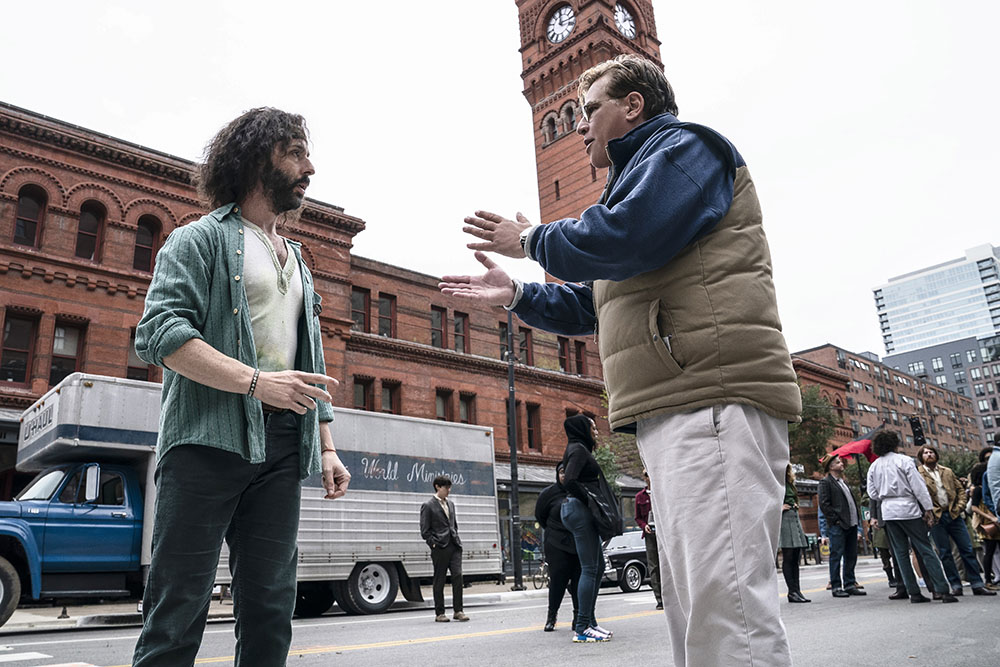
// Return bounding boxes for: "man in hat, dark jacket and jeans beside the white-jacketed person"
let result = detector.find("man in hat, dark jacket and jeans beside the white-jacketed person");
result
[819,456,866,598]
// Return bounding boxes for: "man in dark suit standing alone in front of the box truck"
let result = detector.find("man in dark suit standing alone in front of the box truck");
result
[420,475,469,623]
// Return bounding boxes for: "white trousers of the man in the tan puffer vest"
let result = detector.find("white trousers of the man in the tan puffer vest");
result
[637,404,791,667]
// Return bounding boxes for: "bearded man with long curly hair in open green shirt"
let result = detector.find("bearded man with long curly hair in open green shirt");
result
[133,108,350,667]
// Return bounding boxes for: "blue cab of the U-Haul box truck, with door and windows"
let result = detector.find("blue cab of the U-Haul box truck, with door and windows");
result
[0,463,143,624]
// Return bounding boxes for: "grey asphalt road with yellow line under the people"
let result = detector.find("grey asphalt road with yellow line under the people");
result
[0,559,1000,667]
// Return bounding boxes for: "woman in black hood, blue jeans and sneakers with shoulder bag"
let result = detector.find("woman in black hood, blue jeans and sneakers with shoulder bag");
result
[559,415,611,643]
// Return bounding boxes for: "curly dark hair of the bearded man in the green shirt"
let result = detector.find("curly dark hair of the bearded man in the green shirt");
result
[195,107,309,208]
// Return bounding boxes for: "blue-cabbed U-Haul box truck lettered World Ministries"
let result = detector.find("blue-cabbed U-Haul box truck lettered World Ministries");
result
[0,373,502,628]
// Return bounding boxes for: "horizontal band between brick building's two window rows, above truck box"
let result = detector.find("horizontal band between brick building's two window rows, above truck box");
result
[347,331,604,394]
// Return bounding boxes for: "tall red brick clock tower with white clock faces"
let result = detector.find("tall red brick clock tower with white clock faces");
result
[515,0,660,223]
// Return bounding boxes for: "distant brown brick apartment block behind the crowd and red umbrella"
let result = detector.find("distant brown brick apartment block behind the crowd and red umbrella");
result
[792,344,982,454]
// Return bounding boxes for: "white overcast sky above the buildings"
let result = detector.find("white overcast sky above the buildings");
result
[0,0,1000,356]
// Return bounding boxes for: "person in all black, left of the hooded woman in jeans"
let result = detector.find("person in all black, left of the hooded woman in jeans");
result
[535,463,580,632]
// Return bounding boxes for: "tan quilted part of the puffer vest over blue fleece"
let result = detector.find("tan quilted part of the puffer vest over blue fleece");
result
[594,166,802,430]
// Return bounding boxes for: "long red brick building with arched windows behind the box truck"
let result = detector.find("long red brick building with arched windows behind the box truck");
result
[0,104,606,497]
